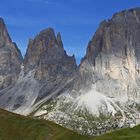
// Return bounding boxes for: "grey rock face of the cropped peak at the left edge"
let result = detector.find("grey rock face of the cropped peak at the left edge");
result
[0,18,22,89]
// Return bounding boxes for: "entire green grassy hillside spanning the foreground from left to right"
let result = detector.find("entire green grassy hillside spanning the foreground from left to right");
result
[0,109,140,140]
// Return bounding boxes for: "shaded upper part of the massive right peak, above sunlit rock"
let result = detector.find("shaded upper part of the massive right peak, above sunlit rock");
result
[86,8,140,63]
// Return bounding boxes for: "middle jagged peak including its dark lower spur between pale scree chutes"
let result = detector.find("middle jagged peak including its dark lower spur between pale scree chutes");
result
[24,28,77,102]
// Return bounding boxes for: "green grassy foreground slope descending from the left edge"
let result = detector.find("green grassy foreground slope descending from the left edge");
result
[0,109,87,140]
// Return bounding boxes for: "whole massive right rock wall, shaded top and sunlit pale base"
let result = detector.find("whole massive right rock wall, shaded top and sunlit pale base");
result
[80,8,140,98]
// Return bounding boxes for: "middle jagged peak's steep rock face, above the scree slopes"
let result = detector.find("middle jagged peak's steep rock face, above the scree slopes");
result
[24,28,76,80]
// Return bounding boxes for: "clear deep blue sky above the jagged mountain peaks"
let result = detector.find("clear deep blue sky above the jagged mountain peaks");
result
[0,0,140,63]
